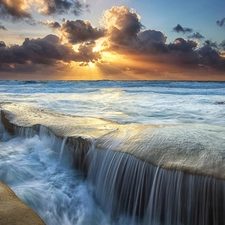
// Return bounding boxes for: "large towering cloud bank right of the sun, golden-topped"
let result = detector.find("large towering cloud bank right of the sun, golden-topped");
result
[96,7,221,74]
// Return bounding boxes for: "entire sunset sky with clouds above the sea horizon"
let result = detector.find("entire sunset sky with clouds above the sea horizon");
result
[0,0,225,81]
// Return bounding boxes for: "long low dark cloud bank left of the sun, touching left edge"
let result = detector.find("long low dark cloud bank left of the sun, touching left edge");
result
[0,35,100,70]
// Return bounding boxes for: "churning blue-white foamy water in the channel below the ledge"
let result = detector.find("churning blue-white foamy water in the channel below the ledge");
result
[0,135,109,225]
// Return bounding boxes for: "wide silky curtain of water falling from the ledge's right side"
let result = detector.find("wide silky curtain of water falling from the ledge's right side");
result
[87,149,225,225]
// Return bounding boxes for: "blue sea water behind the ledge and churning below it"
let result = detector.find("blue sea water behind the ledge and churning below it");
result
[0,81,225,225]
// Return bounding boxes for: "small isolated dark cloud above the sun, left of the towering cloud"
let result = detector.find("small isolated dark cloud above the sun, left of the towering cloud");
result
[61,20,104,44]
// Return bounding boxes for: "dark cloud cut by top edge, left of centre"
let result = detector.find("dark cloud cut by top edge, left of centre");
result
[40,0,88,16]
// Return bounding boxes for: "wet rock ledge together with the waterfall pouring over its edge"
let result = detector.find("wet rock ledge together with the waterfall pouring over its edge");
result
[1,104,225,225]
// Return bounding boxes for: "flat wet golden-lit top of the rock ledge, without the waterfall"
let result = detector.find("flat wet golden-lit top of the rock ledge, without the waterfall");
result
[1,104,225,179]
